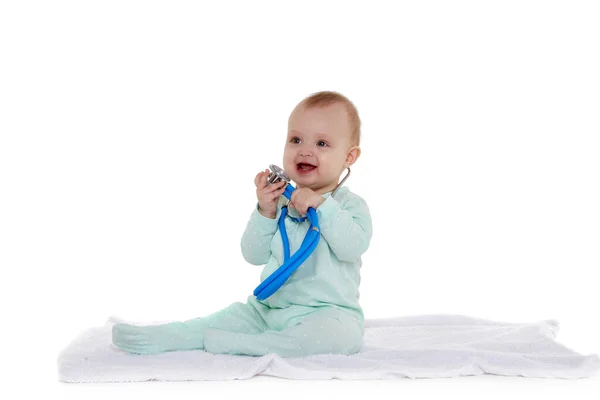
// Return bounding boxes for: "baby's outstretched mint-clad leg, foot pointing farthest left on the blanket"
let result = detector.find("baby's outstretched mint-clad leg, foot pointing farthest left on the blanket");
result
[112,302,267,354]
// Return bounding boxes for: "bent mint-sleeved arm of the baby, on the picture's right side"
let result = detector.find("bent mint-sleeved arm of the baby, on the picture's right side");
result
[317,194,373,261]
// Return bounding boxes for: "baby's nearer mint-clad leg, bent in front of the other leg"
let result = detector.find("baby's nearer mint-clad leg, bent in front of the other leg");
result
[204,311,363,357]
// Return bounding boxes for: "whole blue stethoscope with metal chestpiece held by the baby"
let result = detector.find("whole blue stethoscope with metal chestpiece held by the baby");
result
[254,164,350,300]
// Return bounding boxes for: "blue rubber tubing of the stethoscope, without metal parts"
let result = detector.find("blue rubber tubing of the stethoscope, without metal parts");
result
[254,183,321,300]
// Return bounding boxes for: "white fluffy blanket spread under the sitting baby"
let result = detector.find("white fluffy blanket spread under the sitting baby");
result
[58,315,600,382]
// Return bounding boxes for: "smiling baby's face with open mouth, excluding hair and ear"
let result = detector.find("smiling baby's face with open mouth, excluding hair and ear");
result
[283,104,351,194]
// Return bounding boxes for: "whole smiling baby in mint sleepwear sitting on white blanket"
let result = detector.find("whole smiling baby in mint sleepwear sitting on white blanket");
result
[112,92,372,357]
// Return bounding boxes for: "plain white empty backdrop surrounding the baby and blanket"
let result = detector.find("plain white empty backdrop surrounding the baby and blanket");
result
[0,0,600,399]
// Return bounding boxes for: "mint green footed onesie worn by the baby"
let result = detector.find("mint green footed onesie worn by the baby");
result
[112,186,373,357]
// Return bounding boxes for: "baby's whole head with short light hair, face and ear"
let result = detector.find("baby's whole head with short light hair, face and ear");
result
[283,91,360,194]
